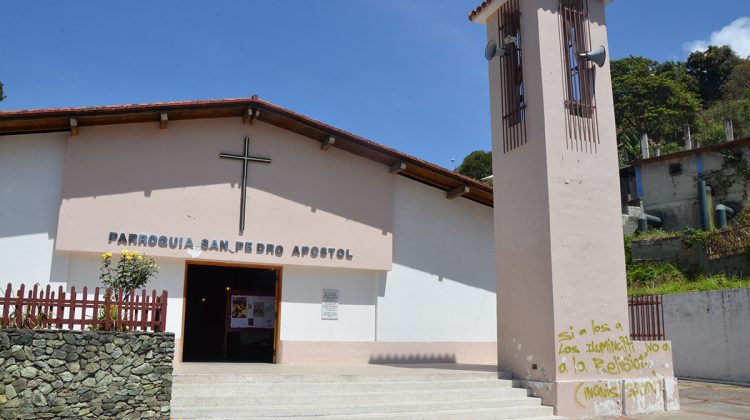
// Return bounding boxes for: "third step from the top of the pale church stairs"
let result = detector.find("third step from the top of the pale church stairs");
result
[172,385,528,407]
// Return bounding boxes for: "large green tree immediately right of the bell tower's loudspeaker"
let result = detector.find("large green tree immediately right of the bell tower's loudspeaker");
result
[611,56,701,148]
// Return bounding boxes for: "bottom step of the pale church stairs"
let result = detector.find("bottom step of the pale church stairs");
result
[172,397,554,419]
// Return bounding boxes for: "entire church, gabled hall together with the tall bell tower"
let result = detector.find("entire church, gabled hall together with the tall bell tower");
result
[0,0,679,418]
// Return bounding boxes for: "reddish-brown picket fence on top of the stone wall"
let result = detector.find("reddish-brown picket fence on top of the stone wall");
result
[0,283,167,331]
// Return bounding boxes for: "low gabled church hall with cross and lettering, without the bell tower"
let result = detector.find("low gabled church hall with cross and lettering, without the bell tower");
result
[0,96,506,364]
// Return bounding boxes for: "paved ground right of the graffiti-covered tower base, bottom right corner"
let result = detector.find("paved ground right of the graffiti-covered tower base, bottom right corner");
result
[617,380,750,420]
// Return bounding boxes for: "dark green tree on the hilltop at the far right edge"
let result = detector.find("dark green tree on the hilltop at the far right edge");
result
[687,45,744,104]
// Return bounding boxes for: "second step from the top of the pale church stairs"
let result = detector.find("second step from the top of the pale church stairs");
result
[172,377,513,395]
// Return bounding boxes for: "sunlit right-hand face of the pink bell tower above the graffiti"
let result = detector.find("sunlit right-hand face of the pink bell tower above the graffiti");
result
[539,0,630,379]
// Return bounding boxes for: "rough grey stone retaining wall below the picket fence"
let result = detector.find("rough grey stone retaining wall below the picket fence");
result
[0,329,174,419]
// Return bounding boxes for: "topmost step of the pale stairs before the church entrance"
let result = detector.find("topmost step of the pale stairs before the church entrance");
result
[174,371,502,384]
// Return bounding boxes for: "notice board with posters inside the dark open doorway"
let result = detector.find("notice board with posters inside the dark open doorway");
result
[227,290,276,331]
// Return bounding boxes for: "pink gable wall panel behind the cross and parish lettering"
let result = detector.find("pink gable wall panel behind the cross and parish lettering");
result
[57,118,393,270]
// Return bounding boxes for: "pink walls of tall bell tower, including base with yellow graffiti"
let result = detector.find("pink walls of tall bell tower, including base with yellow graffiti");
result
[487,0,677,417]
